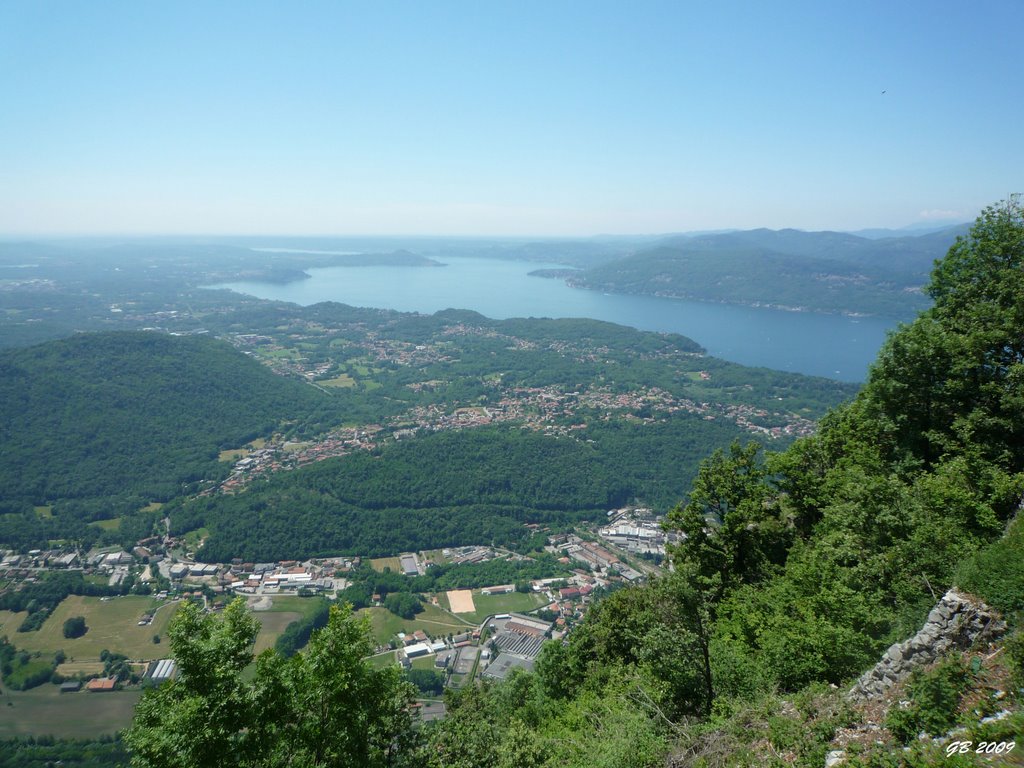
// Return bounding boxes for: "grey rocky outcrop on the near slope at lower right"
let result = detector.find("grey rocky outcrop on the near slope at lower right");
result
[847,590,1007,701]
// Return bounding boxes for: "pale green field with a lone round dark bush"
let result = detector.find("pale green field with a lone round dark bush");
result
[7,595,178,662]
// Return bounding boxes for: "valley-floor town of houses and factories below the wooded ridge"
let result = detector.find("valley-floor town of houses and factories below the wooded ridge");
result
[0,507,676,720]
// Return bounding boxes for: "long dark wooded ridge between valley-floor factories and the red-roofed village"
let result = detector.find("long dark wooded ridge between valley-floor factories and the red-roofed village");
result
[180,416,749,562]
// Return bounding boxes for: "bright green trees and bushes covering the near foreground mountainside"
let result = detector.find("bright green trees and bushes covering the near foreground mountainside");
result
[119,199,1024,768]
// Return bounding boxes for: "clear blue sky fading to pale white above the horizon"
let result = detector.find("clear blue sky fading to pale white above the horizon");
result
[0,0,1024,236]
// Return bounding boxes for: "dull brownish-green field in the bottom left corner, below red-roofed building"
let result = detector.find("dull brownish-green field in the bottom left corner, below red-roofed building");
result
[0,684,141,738]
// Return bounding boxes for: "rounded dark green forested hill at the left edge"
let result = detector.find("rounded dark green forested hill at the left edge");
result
[0,333,334,511]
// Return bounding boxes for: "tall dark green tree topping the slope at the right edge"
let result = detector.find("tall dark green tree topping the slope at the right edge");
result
[864,196,1024,479]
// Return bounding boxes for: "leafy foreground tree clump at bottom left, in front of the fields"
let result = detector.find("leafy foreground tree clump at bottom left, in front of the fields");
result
[125,599,414,768]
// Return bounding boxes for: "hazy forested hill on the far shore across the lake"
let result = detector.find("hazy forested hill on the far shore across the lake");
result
[569,227,964,319]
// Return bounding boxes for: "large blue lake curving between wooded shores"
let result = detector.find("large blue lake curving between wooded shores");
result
[215,257,896,382]
